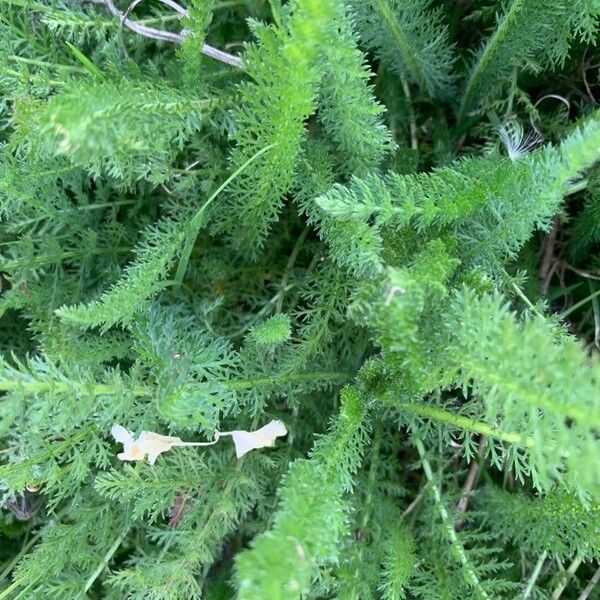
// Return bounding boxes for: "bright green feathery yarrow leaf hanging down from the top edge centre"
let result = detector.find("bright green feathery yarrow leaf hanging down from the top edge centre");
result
[217,0,334,253]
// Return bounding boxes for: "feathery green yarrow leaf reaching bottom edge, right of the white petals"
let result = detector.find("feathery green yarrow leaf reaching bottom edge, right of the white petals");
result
[237,388,367,600]
